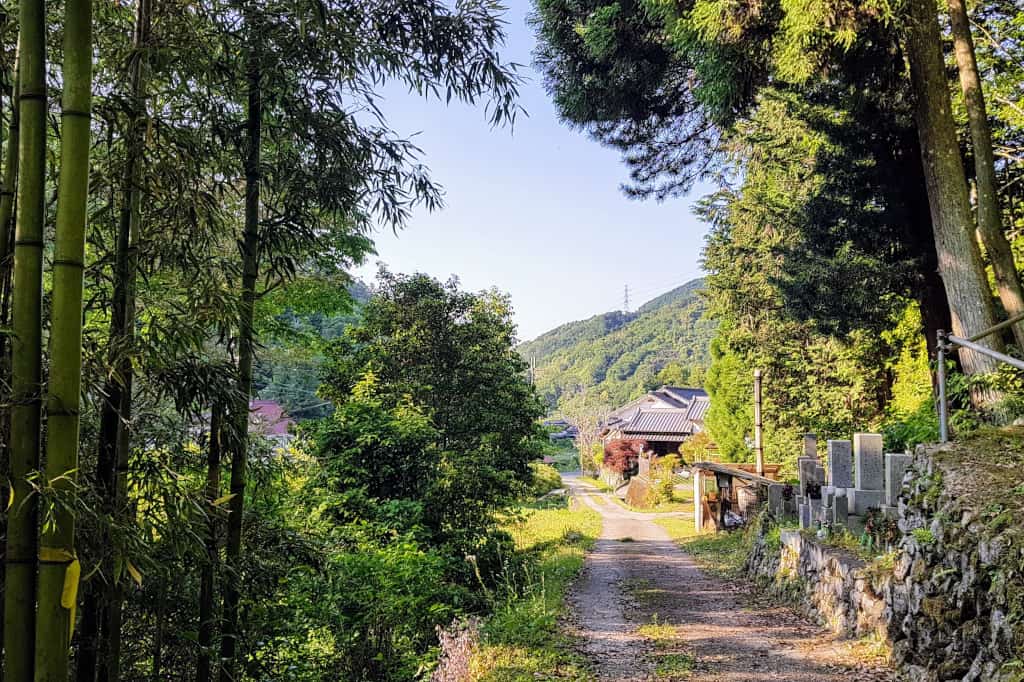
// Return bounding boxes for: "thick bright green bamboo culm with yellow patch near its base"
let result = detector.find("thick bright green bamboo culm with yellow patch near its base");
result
[36,0,92,682]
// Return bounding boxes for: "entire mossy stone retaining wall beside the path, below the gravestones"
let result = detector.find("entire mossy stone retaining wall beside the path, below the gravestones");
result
[748,431,1024,682]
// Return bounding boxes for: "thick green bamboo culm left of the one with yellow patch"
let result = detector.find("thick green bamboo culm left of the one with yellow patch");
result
[4,0,46,682]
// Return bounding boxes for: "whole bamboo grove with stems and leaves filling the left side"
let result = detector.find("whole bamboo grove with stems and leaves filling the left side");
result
[0,0,525,682]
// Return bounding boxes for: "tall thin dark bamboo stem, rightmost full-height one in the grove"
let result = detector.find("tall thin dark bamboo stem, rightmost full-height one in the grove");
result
[220,42,263,682]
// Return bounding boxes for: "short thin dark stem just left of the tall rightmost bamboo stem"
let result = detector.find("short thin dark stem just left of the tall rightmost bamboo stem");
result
[196,402,224,682]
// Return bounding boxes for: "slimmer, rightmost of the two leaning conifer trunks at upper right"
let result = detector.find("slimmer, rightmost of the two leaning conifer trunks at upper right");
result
[948,0,1024,349]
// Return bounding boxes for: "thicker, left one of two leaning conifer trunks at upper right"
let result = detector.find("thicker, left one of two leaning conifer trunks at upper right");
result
[906,0,999,385]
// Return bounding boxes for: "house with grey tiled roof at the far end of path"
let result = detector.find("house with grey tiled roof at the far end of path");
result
[603,386,711,455]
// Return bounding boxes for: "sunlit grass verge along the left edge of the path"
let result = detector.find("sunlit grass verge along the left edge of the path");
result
[471,501,601,682]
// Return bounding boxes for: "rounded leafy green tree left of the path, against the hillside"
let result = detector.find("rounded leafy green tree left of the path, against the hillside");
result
[322,271,544,561]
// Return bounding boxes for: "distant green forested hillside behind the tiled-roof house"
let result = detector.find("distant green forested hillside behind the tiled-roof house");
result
[519,280,715,408]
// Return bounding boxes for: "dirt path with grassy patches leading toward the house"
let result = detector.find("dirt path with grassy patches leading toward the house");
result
[567,479,892,682]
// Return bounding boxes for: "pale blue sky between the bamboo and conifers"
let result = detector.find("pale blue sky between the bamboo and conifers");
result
[358,0,707,340]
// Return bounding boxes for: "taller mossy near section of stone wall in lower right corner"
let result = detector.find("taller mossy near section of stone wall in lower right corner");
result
[888,444,1024,682]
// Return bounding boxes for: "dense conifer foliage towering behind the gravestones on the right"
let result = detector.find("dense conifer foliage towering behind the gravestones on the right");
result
[535,0,1020,458]
